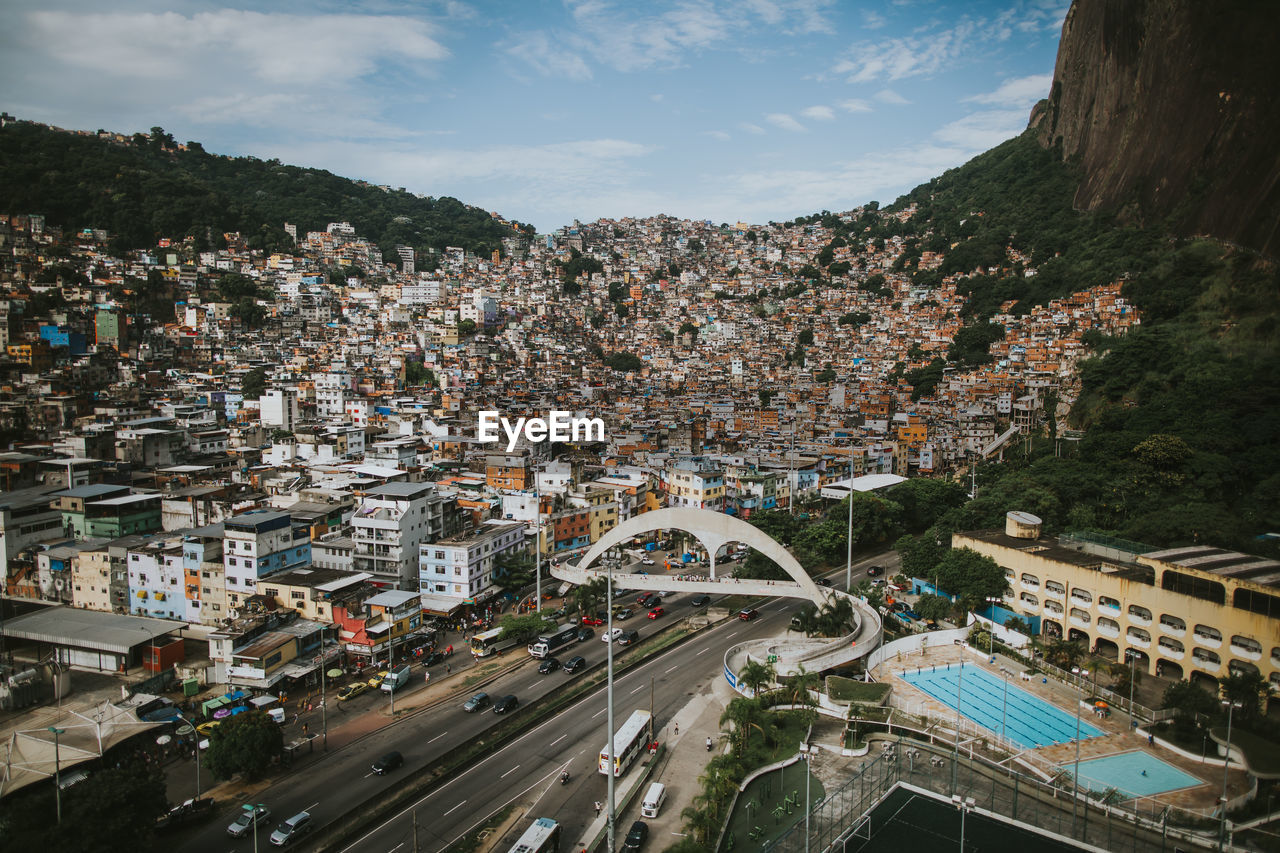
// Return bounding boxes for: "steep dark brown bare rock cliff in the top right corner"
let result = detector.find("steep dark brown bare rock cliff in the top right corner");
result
[1032,0,1280,256]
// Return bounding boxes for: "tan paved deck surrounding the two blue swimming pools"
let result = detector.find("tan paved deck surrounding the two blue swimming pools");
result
[872,637,1249,809]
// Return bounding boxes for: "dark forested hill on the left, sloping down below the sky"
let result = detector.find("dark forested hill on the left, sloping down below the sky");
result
[0,122,529,260]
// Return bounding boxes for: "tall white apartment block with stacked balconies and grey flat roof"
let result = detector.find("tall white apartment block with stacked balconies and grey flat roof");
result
[351,483,444,589]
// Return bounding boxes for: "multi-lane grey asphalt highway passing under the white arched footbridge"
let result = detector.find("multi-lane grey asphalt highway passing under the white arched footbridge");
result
[182,553,892,853]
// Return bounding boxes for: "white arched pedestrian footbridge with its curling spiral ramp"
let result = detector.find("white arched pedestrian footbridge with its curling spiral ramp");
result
[552,507,883,686]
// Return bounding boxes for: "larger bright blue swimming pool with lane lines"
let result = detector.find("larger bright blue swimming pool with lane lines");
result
[901,663,1102,749]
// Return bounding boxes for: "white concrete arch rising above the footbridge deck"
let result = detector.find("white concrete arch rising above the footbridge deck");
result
[570,507,831,607]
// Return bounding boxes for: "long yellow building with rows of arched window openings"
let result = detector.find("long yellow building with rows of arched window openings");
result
[951,512,1280,689]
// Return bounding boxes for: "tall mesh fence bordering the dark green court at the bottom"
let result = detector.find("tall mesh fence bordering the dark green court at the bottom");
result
[765,733,1215,853]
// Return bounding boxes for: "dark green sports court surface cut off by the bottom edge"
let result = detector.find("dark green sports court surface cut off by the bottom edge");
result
[845,788,1085,853]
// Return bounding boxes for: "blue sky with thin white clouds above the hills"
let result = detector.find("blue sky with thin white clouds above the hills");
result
[0,0,1068,232]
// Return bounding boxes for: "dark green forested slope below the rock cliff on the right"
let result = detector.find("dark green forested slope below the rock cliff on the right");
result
[879,131,1280,553]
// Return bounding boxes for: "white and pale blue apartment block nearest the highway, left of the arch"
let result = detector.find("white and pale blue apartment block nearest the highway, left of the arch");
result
[419,520,525,615]
